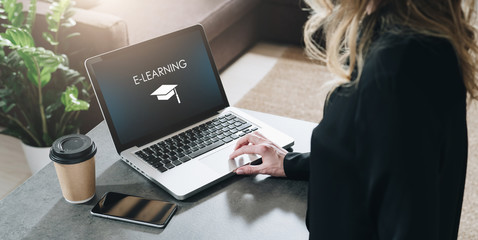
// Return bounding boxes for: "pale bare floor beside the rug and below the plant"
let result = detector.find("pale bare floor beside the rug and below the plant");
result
[0,43,287,199]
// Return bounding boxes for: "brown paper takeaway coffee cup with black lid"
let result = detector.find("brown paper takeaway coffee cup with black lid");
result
[50,134,96,204]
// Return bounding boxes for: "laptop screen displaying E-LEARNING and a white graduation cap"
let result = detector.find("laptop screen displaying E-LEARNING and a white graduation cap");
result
[85,25,228,152]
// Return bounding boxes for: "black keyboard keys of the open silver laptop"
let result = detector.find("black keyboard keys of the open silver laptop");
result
[131,113,257,172]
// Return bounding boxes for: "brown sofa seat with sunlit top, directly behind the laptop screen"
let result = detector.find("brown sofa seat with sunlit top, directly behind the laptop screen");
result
[90,0,261,70]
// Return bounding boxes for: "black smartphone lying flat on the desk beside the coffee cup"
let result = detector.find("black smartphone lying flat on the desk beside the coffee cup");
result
[91,192,178,228]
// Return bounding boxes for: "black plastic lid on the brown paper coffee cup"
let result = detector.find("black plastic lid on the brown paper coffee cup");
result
[50,134,96,164]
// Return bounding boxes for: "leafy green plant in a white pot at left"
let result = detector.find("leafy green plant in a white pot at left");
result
[0,0,90,173]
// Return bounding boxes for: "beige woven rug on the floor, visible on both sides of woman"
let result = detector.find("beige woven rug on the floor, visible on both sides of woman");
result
[236,47,478,240]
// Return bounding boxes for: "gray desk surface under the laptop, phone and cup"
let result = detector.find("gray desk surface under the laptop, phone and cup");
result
[0,111,316,239]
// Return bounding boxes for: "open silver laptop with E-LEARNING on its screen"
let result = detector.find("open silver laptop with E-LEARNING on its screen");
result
[85,25,294,200]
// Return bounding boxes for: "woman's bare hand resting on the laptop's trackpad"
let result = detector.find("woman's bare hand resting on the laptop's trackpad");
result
[230,132,287,177]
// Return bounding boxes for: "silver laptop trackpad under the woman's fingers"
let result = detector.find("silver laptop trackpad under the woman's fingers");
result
[200,145,260,174]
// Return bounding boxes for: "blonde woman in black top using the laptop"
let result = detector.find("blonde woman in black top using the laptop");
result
[231,0,478,240]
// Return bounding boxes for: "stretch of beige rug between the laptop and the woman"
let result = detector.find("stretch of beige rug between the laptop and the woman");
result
[235,47,333,123]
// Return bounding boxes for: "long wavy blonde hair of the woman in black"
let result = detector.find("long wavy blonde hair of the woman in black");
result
[304,0,478,100]
